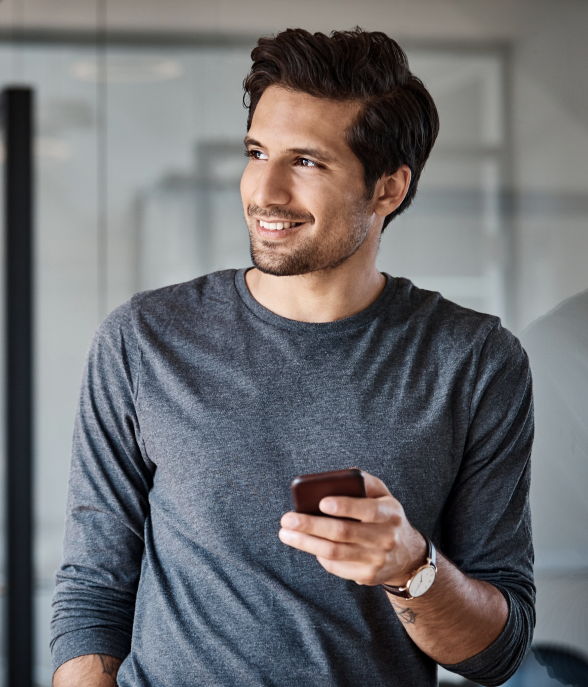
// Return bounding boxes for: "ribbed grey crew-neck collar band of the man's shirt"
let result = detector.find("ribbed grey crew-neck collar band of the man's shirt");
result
[235,267,397,335]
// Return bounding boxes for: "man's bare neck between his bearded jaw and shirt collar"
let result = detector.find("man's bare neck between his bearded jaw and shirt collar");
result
[245,256,386,322]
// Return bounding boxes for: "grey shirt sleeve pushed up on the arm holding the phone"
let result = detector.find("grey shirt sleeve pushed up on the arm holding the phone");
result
[441,324,535,687]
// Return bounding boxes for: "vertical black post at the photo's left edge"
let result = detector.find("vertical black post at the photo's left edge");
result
[2,88,33,687]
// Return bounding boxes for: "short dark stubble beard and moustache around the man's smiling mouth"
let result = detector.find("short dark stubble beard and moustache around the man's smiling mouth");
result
[246,200,371,277]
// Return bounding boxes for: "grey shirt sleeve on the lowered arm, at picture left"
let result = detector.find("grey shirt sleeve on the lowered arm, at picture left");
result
[51,303,154,670]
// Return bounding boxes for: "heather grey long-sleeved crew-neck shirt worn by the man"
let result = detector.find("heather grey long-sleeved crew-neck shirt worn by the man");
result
[52,270,534,687]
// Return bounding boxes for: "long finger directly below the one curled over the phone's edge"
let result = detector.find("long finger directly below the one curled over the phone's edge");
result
[281,512,396,548]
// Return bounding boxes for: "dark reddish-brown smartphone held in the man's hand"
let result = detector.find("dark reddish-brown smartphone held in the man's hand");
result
[290,468,366,517]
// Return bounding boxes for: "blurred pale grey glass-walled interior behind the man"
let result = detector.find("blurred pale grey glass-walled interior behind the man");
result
[0,0,588,687]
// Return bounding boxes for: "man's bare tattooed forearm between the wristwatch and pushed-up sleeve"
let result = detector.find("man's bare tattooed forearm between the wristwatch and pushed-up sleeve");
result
[388,554,508,664]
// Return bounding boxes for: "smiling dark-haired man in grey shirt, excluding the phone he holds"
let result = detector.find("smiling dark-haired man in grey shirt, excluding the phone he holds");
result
[52,29,534,687]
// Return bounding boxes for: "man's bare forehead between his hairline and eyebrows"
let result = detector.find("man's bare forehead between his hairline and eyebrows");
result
[249,86,359,157]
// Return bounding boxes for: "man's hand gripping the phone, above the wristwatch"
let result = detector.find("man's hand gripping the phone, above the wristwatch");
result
[278,472,427,586]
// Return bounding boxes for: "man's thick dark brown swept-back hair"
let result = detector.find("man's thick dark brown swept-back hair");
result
[243,27,439,227]
